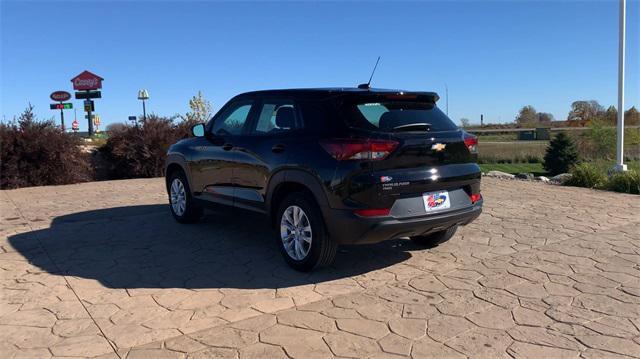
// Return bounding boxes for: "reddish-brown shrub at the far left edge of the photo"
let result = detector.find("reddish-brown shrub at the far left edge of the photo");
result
[0,105,92,189]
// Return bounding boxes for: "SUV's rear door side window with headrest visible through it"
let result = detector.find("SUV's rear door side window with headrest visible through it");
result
[251,100,302,135]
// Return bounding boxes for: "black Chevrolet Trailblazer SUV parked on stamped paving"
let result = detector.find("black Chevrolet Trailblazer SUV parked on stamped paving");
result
[166,88,482,271]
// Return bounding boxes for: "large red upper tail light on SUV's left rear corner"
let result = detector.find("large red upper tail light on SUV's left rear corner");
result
[320,138,398,161]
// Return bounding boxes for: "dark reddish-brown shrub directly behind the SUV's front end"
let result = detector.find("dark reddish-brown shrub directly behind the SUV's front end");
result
[100,115,192,179]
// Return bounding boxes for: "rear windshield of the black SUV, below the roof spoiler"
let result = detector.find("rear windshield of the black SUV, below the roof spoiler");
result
[341,101,457,132]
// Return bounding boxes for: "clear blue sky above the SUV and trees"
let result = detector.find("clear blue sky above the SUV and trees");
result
[0,0,640,129]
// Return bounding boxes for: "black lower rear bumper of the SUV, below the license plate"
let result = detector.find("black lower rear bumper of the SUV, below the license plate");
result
[323,200,483,244]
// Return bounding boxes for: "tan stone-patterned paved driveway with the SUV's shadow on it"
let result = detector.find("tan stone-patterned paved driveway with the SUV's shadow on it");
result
[0,179,640,358]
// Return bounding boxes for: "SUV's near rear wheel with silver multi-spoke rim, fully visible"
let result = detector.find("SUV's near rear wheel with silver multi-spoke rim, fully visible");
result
[275,192,337,272]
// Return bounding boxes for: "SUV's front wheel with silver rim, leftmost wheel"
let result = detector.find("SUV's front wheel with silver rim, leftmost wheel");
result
[168,170,204,223]
